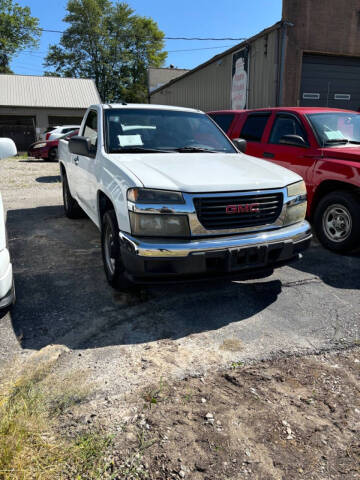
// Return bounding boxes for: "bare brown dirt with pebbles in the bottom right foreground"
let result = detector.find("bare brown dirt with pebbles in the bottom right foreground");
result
[63,348,360,480]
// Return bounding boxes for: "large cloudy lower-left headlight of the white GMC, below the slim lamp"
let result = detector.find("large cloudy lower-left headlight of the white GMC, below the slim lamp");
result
[129,212,190,237]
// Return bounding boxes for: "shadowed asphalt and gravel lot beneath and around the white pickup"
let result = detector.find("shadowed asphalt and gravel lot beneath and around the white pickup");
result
[0,159,360,395]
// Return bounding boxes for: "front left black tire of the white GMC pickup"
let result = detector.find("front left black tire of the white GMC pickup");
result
[101,210,134,291]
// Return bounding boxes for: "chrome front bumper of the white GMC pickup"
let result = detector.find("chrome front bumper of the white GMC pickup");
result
[120,220,312,258]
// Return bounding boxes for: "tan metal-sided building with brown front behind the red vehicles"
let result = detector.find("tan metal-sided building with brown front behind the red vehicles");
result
[150,0,360,111]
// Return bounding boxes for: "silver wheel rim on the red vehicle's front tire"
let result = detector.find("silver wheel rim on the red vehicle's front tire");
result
[323,204,352,243]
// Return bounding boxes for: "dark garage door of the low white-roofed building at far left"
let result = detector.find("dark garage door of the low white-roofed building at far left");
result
[0,115,35,152]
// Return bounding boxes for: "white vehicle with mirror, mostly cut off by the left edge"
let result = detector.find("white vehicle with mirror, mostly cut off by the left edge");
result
[0,138,17,310]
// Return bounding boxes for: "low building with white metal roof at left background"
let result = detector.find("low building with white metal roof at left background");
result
[0,75,100,151]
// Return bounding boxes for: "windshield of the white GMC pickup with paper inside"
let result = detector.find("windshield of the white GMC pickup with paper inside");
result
[105,108,236,153]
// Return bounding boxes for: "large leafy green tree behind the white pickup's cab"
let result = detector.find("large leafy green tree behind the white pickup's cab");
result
[45,0,167,102]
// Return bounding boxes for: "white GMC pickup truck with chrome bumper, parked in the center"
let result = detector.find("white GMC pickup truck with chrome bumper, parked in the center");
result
[59,103,311,289]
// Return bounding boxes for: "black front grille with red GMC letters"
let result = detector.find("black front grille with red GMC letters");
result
[194,193,283,230]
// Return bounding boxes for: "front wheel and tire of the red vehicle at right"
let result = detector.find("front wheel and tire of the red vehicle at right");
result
[314,191,360,253]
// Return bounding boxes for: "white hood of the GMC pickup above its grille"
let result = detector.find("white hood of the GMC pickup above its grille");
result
[119,153,301,193]
